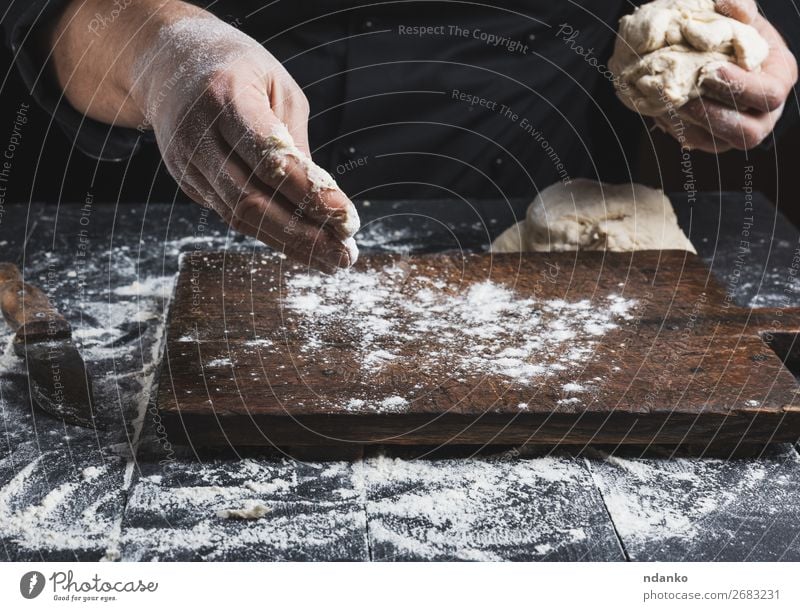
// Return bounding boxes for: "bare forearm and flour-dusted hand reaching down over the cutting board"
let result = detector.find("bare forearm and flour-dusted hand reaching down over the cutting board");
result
[54,0,359,272]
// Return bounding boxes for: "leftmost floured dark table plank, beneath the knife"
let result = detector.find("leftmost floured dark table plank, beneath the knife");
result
[0,204,184,561]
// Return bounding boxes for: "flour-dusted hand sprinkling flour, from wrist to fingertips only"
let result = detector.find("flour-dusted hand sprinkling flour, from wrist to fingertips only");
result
[132,13,359,272]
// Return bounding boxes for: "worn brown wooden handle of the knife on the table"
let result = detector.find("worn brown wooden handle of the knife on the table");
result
[0,263,72,341]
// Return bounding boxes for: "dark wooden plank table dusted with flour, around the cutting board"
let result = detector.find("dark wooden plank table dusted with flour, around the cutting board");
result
[0,193,800,560]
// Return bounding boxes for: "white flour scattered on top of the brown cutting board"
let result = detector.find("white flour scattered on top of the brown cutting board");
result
[284,265,635,411]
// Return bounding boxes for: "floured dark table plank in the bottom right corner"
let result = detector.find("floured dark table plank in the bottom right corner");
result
[586,444,800,562]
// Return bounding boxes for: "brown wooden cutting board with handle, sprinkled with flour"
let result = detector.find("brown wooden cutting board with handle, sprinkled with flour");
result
[158,251,800,446]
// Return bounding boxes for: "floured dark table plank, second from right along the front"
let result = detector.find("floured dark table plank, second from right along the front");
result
[361,448,624,561]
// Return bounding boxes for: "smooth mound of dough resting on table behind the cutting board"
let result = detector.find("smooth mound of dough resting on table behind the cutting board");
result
[492,179,696,253]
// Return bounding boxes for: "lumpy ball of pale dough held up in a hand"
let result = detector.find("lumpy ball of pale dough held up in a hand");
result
[608,0,769,116]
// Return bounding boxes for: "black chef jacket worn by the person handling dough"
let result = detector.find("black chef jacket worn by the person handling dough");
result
[0,0,800,198]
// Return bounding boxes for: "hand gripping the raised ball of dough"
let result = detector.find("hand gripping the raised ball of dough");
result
[655,0,797,153]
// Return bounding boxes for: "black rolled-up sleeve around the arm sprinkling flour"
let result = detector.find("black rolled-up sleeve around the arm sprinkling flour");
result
[0,0,153,161]
